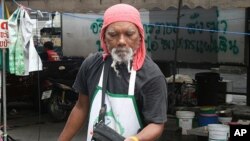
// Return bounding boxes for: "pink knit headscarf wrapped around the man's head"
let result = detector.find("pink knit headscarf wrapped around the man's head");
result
[100,4,146,71]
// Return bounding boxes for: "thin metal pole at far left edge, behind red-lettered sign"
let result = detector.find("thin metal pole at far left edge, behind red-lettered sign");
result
[1,0,7,141]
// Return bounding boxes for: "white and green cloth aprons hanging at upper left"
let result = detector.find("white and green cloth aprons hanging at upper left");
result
[8,7,42,76]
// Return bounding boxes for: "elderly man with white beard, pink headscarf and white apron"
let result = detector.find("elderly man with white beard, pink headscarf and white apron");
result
[59,4,167,141]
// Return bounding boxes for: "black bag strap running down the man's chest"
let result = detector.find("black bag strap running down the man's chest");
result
[98,62,110,122]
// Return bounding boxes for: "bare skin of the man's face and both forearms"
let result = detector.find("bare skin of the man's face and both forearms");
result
[58,22,164,141]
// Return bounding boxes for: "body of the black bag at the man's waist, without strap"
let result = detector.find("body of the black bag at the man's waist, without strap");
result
[91,122,125,141]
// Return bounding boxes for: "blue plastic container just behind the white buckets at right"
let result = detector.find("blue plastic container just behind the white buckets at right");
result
[198,114,219,126]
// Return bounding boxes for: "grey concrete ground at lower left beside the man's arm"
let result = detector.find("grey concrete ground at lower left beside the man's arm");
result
[7,108,86,141]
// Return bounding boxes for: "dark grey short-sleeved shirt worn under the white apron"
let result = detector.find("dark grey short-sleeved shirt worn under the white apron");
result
[73,53,167,125]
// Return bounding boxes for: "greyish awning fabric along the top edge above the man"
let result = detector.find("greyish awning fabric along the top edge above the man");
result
[6,0,250,13]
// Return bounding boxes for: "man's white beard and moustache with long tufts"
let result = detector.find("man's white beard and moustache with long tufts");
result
[111,47,133,76]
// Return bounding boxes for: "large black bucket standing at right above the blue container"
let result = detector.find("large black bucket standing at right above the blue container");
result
[195,72,220,106]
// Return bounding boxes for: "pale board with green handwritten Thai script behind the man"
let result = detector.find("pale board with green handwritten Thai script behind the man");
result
[63,8,245,64]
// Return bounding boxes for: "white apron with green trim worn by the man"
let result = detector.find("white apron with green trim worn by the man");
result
[87,66,142,141]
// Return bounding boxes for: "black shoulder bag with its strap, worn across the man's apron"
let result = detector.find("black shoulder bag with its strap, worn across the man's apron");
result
[91,63,125,141]
